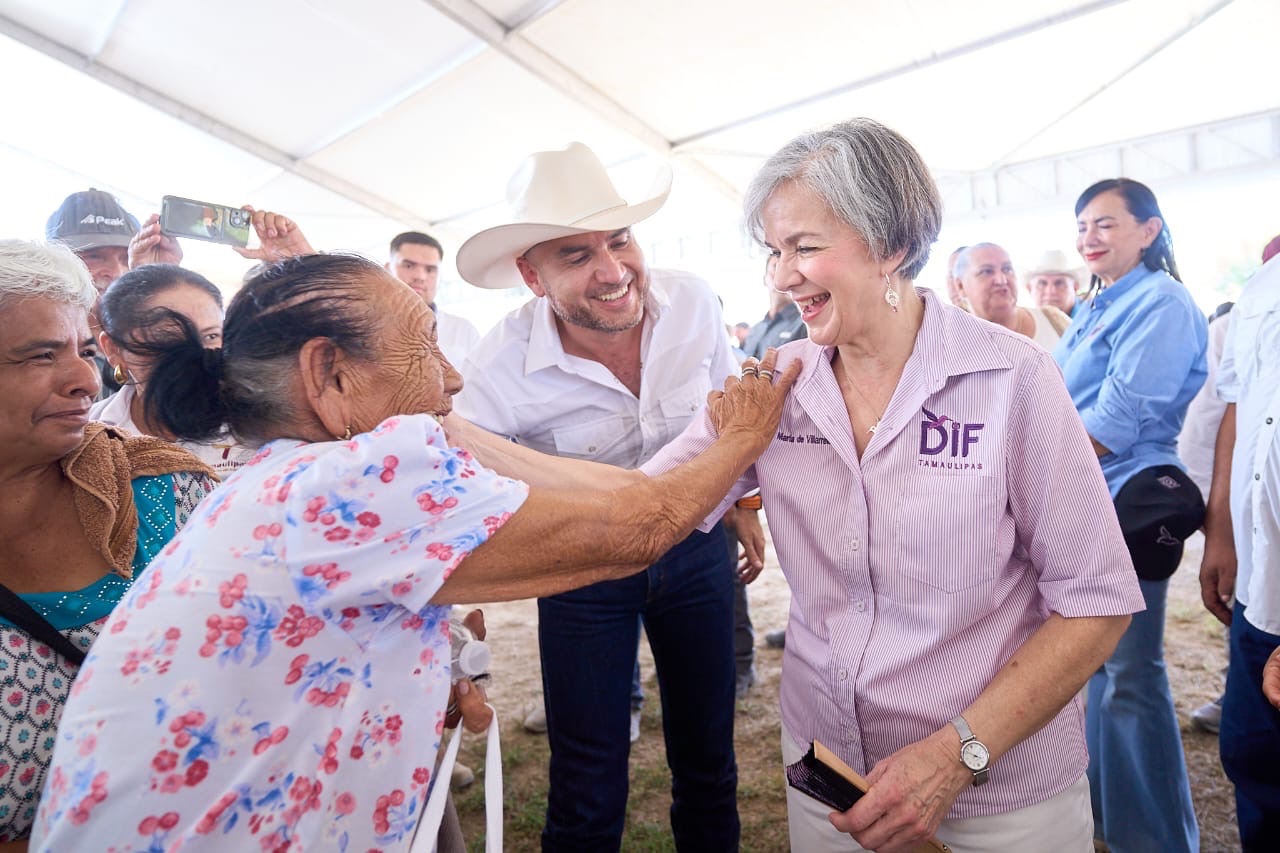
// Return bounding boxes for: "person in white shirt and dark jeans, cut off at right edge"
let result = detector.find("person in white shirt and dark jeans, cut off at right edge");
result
[1201,244,1280,852]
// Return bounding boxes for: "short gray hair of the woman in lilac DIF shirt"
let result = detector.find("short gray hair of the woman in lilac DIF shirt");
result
[742,118,942,280]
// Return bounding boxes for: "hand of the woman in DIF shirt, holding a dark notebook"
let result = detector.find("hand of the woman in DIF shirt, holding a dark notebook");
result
[831,730,973,853]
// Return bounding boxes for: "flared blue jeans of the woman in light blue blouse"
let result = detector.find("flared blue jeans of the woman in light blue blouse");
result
[1084,580,1199,853]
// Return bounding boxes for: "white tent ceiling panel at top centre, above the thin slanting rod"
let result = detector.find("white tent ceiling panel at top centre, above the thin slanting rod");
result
[525,0,1107,140]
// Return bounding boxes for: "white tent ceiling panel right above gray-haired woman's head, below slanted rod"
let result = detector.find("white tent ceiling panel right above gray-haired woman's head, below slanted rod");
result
[665,0,1264,174]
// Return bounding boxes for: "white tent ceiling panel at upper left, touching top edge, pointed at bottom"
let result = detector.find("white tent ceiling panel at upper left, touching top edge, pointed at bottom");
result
[83,0,479,158]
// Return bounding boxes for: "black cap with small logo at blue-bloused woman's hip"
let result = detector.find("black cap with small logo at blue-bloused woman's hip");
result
[1116,465,1204,580]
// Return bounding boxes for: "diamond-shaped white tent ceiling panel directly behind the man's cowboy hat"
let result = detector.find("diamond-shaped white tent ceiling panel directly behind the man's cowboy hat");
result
[308,51,641,222]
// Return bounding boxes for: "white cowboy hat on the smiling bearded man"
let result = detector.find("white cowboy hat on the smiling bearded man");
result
[457,142,671,289]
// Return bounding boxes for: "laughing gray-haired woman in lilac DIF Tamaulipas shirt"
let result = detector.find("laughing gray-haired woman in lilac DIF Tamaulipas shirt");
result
[643,119,1142,852]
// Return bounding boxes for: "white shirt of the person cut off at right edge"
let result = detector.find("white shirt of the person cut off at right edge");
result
[1217,259,1280,634]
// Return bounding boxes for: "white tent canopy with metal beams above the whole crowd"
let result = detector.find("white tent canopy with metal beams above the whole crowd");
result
[0,0,1280,325]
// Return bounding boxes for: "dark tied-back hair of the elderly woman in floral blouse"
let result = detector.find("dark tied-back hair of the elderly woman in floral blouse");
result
[133,254,387,444]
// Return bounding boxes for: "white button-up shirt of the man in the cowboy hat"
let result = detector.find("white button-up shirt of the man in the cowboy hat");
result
[456,269,737,467]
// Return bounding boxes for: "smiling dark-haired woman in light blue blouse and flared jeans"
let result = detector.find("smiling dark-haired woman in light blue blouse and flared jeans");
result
[1053,178,1208,853]
